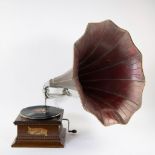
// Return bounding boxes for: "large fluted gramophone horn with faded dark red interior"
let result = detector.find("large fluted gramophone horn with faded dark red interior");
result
[47,20,145,126]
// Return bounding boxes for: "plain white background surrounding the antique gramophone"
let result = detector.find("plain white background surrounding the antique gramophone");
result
[0,0,155,155]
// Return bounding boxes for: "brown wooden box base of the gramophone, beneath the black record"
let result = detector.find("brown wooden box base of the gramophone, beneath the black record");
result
[12,111,66,148]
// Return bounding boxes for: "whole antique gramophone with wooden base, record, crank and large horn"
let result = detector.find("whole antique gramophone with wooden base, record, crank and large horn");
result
[12,20,145,147]
